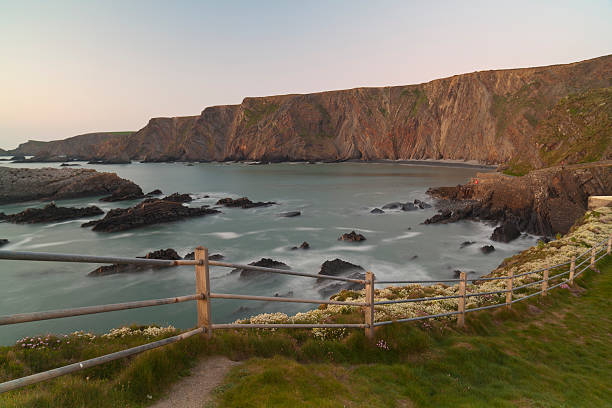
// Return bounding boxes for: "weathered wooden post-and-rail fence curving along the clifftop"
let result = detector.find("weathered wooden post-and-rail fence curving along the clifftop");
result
[0,236,612,393]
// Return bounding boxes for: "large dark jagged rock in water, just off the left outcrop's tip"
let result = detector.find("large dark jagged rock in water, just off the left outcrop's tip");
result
[82,198,220,232]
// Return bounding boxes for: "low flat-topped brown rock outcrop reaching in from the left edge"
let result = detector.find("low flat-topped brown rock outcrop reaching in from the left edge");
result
[0,167,140,204]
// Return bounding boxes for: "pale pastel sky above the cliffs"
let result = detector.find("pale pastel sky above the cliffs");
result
[0,0,612,149]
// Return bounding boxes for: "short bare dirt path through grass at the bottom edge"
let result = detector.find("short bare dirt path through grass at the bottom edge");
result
[151,356,240,408]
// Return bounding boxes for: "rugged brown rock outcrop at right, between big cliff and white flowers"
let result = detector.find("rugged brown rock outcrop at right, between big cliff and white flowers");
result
[425,161,612,235]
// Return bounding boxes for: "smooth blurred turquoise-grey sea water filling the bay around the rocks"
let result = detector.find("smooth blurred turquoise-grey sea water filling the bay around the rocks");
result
[0,163,536,344]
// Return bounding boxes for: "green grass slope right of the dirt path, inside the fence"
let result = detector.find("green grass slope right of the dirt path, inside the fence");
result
[216,258,612,407]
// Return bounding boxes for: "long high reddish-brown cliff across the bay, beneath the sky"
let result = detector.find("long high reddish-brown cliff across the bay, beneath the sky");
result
[10,55,612,167]
